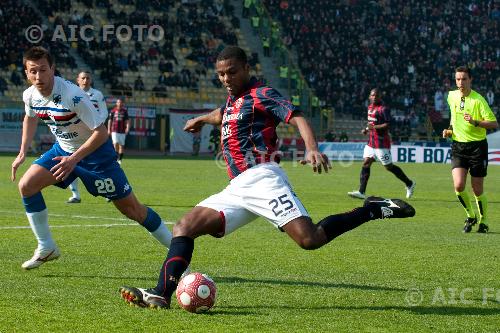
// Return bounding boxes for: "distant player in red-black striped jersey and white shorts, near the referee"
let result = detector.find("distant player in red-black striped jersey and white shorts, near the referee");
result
[347,88,416,199]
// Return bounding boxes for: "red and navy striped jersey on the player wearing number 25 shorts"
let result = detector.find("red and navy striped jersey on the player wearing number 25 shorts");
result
[221,78,296,179]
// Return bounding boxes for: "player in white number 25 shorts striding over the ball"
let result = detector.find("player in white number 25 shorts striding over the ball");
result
[120,46,415,308]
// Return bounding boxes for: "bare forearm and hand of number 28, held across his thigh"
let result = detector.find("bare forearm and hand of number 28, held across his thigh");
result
[50,124,108,181]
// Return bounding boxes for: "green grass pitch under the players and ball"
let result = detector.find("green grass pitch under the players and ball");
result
[0,155,500,333]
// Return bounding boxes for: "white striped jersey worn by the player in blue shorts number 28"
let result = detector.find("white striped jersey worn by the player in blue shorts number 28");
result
[23,76,106,153]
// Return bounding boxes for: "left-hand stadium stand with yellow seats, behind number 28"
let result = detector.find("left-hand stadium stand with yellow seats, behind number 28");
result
[0,0,262,107]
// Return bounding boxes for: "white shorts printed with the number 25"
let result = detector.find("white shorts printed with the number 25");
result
[197,162,309,237]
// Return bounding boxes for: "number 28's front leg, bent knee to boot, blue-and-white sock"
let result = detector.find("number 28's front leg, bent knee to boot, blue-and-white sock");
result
[18,164,60,269]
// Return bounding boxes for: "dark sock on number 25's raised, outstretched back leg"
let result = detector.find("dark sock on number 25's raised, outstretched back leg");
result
[318,204,381,242]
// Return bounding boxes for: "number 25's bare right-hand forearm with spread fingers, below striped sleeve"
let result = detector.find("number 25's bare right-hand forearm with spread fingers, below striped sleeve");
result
[289,112,332,173]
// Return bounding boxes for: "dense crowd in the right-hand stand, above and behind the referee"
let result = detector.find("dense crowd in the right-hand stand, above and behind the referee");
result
[264,0,500,128]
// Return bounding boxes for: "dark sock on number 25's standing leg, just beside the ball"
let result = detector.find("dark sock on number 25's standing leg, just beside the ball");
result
[154,236,194,299]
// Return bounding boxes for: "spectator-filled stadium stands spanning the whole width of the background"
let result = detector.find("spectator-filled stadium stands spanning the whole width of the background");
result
[0,0,500,145]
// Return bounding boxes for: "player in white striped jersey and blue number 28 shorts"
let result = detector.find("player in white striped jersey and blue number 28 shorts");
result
[11,46,172,269]
